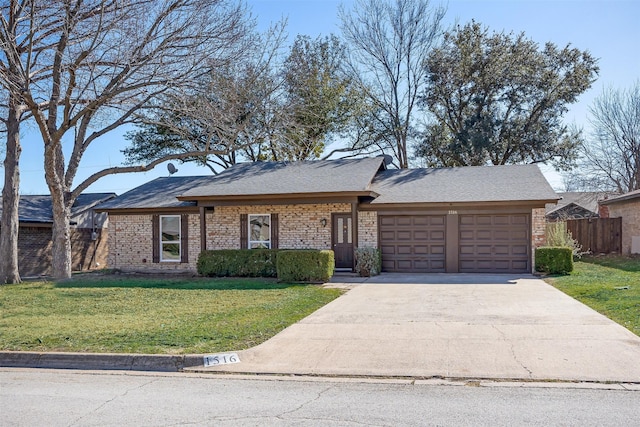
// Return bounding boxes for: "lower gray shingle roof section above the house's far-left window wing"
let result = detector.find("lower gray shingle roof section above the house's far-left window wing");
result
[99,175,216,210]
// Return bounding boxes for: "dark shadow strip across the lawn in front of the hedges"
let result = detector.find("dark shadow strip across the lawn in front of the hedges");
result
[55,277,304,290]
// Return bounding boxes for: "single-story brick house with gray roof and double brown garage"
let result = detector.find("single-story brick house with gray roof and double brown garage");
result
[99,157,558,273]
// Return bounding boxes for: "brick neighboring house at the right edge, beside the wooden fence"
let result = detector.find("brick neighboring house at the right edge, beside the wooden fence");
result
[600,190,640,255]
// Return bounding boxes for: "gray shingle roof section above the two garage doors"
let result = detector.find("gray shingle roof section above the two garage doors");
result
[371,165,558,205]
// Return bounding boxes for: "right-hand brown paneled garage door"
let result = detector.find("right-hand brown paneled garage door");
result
[459,214,531,273]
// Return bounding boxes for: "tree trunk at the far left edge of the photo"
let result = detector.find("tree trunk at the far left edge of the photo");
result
[0,101,22,284]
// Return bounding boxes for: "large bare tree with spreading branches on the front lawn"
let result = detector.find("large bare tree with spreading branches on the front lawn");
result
[3,0,248,278]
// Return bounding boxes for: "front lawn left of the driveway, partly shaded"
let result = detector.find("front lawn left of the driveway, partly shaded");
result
[0,275,341,354]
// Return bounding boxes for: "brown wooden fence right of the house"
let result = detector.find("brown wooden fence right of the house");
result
[567,218,622,254]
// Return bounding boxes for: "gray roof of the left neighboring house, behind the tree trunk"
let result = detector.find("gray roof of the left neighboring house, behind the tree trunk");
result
[0,193,116,223]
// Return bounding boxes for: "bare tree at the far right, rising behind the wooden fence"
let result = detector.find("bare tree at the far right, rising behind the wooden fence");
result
[579,81,640,193]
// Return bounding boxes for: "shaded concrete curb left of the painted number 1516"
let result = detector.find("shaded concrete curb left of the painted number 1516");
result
[0,351,204,372]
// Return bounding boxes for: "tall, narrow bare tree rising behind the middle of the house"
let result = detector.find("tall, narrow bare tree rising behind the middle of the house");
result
[339,0,446,168]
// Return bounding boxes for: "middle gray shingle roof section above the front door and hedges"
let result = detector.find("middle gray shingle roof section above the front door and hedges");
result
[181,157,383,199]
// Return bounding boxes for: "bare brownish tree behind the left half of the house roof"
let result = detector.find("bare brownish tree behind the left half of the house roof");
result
[123,22,286,174]
